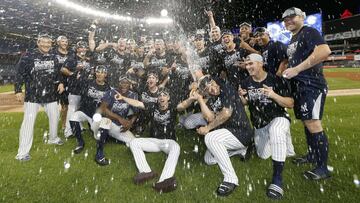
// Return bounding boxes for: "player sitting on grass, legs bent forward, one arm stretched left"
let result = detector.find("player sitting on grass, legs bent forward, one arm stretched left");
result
[118,88,180,192]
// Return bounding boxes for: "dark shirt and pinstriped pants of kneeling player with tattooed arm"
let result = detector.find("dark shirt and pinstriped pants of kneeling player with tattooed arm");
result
[204,78,254,185]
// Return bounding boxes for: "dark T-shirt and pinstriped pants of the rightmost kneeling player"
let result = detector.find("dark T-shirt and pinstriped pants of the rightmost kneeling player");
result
[241,73,295,162]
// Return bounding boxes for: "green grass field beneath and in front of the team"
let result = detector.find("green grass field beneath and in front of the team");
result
[0,96,360,202]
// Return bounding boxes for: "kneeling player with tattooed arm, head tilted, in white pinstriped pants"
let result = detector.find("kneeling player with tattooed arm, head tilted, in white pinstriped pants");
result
[194,76,254,196]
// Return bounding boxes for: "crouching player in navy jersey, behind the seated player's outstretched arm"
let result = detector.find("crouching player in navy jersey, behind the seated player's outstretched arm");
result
[95,76,138,166]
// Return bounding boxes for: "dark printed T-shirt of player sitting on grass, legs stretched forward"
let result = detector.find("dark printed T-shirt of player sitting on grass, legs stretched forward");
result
[145,103,177,140]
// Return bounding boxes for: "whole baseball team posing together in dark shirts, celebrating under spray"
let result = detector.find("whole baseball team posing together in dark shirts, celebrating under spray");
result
[15,7,331,199]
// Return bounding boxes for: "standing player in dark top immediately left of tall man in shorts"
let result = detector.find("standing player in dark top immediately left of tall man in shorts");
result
[254,27,288,77]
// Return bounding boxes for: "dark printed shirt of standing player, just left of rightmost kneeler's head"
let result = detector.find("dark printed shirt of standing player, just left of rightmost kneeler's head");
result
[223,48,249,89]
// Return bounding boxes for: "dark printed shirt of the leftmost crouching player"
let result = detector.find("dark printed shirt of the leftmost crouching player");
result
[79,79,110,118]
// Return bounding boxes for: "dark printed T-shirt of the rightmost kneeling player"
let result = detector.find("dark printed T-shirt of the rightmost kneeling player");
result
[241,73,291,128]
